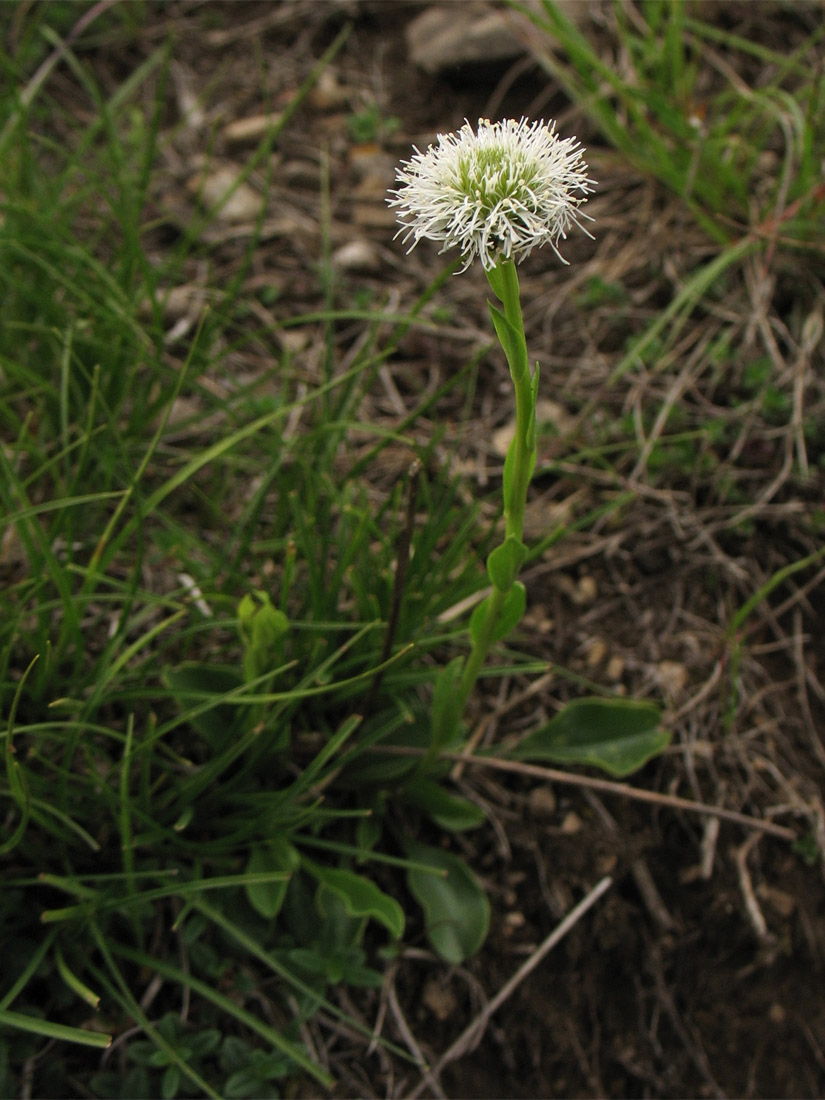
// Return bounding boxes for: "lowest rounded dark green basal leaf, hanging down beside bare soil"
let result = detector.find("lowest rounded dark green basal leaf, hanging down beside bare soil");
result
[405,840,490,966]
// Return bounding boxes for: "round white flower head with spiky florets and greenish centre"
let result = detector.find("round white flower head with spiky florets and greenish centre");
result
[388,118,594,271]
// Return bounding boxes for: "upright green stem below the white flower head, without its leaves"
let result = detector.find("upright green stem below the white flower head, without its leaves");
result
[458,260,536,717]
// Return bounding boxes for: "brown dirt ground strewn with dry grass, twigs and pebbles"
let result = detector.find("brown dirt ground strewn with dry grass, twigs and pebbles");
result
[45,0,825,1097]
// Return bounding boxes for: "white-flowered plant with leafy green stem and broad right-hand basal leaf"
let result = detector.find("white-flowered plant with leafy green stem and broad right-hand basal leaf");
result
[388,118,668,774]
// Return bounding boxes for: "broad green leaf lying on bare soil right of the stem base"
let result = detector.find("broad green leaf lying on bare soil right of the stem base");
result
[510,699,670,777]
